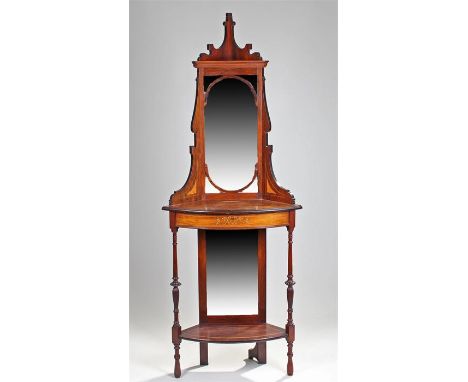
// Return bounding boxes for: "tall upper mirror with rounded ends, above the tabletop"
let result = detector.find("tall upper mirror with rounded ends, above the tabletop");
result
[205,76,257,190]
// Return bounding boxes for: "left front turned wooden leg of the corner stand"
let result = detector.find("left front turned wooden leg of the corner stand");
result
[170,227,181,378]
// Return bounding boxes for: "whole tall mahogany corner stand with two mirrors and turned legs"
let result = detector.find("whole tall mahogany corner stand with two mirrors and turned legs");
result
[163,13,302,377]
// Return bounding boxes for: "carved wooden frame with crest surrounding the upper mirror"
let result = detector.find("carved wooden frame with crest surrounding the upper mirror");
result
[169,14,295,205]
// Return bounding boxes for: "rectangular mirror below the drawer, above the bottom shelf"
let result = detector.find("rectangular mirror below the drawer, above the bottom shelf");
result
[206,230,258,315]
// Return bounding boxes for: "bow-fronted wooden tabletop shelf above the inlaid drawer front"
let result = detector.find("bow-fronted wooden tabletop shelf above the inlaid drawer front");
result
[162,199,302,215]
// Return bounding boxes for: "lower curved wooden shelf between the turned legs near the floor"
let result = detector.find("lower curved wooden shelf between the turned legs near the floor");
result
[180,324,286,343]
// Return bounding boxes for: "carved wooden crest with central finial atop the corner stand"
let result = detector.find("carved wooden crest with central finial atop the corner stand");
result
[198,13,262,61]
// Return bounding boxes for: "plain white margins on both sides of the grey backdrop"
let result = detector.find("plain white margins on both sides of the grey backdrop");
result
[0,0,468,382]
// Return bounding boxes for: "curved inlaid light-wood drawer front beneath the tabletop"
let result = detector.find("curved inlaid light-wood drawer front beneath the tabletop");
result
[175,212,289,229]
